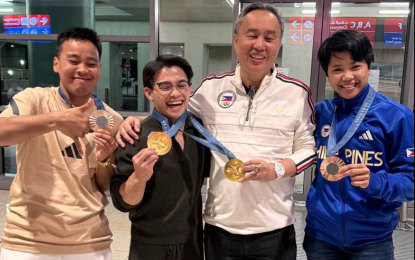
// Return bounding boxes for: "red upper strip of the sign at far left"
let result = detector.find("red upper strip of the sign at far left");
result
[3,15,50,28]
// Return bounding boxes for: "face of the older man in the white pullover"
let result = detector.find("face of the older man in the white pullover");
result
[233,10,281,76]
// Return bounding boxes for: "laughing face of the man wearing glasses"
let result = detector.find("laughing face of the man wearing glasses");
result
[145,66,192,123]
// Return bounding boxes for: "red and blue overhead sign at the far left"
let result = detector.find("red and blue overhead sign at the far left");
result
[3,15,51,34]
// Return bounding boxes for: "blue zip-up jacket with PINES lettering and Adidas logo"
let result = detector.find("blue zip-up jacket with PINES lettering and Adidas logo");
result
[306,85,414,247]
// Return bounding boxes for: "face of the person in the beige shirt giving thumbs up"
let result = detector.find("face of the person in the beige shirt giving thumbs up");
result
[53,40,101,97]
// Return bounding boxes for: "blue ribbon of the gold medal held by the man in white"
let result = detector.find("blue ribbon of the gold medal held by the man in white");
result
[183,116,236,160]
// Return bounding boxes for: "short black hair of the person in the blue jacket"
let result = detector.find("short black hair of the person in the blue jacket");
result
[318,30,375,75]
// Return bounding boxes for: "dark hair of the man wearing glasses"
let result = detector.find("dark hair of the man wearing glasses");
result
[143,54,194,89]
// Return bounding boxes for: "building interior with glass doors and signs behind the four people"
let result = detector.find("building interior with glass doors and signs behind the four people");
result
[0,0,414,256]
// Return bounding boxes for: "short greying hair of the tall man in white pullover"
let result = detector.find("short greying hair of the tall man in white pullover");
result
[233,2,285,39]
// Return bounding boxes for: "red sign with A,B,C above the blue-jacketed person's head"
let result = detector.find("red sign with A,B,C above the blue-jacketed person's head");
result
[330,17,376,45]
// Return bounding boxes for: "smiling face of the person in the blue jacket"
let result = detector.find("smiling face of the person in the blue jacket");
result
[328,51,370,99]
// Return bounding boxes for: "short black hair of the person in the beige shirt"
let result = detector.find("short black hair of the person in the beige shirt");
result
[56,27,102,60]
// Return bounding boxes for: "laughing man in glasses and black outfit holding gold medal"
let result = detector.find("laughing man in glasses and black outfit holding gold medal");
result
[111,55,210,260]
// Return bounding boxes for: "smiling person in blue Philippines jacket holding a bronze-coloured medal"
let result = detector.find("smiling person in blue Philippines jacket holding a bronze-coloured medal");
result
[304,31,414,260]
